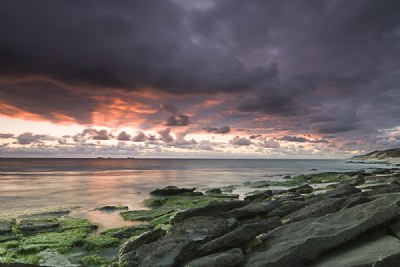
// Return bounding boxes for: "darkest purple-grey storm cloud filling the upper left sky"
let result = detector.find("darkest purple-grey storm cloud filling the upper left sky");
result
[0,0,275,96]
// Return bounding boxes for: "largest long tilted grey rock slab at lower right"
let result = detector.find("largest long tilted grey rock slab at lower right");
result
[245,195,400,267]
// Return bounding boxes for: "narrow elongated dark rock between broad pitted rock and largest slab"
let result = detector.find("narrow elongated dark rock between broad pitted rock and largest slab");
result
[198,217,282,255]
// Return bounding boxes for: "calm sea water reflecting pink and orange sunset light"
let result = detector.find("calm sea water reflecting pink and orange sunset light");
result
[0,158,390,230]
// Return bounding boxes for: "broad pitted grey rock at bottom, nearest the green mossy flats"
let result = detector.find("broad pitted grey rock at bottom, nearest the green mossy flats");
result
[120,217,231,267]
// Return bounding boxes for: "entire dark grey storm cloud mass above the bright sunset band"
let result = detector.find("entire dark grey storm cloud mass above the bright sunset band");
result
[0,0,400,151]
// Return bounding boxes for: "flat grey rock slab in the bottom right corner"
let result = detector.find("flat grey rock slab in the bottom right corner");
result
[310,234,400,267]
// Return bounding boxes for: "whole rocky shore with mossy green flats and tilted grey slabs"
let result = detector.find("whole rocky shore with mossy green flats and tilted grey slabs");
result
[0,168,400,267]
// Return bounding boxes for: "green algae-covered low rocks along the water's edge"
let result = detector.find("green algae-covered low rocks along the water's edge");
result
[0,162,400,266]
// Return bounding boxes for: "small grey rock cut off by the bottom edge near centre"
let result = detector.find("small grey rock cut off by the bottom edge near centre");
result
[184,248,244,267]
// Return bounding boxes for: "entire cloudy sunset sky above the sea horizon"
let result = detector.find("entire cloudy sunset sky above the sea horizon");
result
[0,0,400,158]
